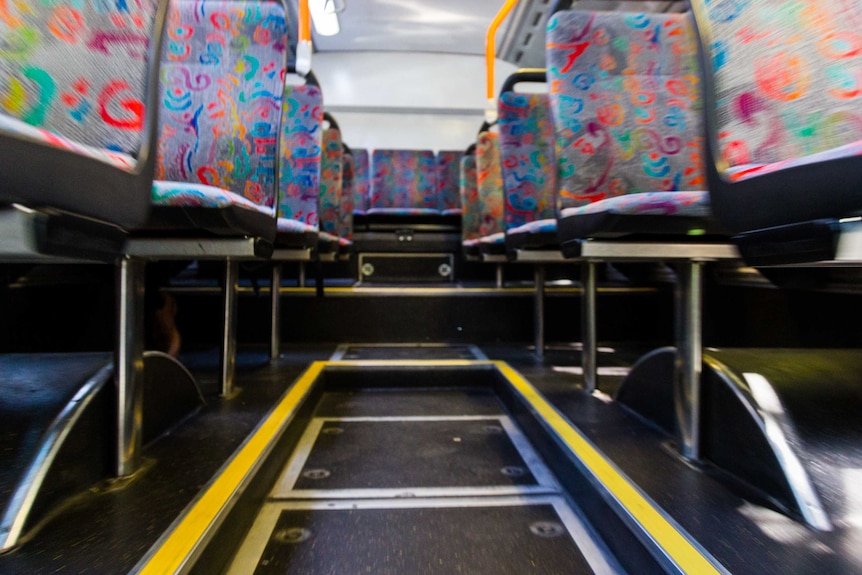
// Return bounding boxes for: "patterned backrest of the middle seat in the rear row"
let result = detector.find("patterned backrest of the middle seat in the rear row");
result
[368,150,440,215]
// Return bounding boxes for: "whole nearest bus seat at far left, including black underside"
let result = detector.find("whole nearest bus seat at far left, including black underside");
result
[0,0,167,257]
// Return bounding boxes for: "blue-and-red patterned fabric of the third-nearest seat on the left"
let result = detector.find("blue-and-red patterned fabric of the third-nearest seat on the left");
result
[278,85,323,230]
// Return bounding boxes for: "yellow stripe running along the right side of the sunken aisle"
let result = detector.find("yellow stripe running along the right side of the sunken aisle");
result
[494,361,724,575]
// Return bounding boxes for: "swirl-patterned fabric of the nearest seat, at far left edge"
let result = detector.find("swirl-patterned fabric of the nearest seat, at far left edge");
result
[0,0,157,162]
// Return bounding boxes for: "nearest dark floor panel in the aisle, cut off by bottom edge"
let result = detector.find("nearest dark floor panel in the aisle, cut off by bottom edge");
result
[254,505,592,575]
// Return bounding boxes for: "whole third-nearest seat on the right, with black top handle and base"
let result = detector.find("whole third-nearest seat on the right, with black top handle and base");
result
[497,69,558,252]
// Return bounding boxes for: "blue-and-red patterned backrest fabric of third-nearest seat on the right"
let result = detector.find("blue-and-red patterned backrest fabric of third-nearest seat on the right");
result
[497,92,557,231]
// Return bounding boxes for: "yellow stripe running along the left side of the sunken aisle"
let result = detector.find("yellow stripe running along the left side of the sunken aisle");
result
[139,361,327,575]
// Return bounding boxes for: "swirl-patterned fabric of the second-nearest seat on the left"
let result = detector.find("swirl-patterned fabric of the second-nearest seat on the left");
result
[154,0,287,216]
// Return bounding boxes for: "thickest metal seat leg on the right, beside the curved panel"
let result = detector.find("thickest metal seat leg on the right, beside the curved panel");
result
[674,260,703,461]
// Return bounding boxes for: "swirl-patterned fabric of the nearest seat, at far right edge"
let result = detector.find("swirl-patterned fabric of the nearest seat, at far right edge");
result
[692,0,862,180]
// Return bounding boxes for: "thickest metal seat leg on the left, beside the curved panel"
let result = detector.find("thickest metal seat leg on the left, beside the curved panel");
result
[114,256,145,477]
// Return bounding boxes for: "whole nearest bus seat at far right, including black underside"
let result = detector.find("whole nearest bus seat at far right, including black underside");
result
[691,0,862,265]
